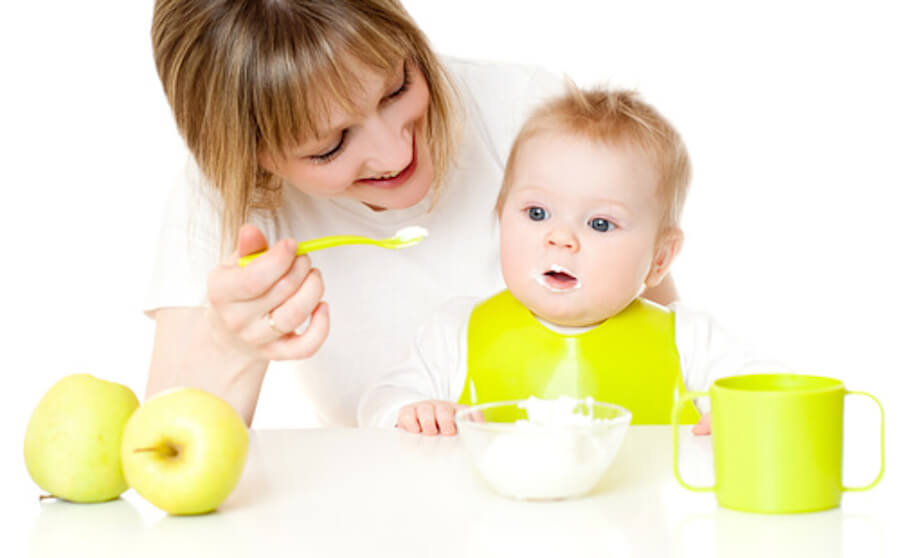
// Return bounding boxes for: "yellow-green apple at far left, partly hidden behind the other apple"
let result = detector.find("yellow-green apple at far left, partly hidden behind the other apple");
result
[25,374,138,502]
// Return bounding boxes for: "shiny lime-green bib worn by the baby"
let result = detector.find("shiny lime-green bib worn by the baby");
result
[459,291,700,424]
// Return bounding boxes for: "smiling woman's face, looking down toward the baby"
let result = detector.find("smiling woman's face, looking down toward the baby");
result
[260,58,434,209]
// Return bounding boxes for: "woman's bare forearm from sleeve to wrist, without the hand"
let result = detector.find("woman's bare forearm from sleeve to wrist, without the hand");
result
[146,308,269,426]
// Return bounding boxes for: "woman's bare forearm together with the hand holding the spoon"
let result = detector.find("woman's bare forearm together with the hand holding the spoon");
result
[147,225,329,426]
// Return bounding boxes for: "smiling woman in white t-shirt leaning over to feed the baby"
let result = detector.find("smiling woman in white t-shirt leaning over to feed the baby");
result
[147,0,674,426]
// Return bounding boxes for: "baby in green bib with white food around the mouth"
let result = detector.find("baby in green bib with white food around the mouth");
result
[358,86,761,435]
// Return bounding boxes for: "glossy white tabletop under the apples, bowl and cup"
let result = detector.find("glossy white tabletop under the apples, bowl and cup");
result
[15,426,900,558]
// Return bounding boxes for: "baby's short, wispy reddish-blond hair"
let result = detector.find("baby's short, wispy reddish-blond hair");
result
[496,82,691,233]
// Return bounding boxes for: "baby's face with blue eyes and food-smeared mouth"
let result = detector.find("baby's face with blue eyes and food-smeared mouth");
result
[500,133,676,326]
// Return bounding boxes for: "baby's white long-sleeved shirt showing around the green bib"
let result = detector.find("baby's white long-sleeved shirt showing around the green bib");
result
[358,298,786,428]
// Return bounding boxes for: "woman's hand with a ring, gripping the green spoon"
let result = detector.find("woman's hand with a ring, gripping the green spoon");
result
[207,225,329,361]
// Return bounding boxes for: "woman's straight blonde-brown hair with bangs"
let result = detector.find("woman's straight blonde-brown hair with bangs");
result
[152,0,455,247]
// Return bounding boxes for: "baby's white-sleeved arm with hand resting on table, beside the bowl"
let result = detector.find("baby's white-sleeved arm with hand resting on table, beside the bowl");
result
[357,299,477,434]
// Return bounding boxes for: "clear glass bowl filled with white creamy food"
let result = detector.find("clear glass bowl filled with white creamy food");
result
[456,397,631,500]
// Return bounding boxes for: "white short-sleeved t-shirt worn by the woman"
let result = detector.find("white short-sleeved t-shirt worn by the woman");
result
[145,59,563,426]
